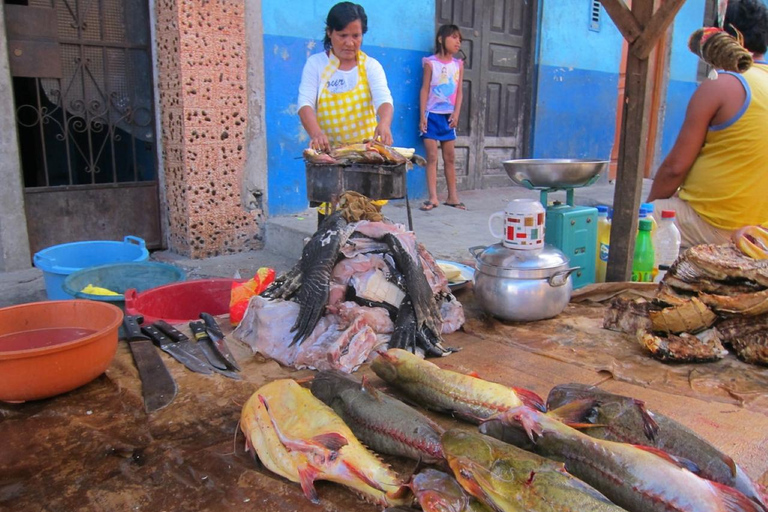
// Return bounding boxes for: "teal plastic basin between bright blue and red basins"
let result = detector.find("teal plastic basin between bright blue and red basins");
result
[63,261,186,309]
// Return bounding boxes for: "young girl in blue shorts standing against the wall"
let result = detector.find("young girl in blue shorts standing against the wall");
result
[419,25,467,211]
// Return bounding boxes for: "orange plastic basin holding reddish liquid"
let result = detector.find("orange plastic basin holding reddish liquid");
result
[0,300,123,402]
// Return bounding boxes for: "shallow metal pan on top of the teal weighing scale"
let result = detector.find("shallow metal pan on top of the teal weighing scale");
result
[502,158,609,188]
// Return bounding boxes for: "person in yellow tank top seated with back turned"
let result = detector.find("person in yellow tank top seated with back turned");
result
[647,0,768,247]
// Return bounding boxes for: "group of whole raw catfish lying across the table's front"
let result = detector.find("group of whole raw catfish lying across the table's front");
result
[240,349,768,512]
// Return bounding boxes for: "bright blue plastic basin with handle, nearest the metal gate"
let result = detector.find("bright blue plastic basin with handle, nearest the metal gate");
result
[34,236,149,300]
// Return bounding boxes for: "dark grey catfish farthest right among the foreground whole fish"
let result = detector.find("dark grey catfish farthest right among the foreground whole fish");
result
[547,383,768,508]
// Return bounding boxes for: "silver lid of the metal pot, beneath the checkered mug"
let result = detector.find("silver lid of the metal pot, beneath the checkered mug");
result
[475,243,569,278]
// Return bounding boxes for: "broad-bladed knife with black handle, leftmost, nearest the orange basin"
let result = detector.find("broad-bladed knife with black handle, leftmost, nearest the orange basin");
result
[123,315,176,413]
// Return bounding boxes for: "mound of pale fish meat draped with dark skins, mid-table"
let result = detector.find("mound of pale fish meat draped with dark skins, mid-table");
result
[233,209,464,372]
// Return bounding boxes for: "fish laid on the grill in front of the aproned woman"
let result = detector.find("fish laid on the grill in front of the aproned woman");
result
[303,140,427,166]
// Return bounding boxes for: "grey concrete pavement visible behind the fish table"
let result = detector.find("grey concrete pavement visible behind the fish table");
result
[0,180,651,307]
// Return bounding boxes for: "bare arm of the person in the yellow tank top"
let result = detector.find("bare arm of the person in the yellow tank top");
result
[646,75,744,202]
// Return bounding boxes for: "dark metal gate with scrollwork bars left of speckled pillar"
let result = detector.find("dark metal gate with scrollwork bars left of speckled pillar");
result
[5,0,162,255]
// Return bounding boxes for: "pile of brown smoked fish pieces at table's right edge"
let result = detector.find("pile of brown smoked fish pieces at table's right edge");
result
[603,243,768,365]
